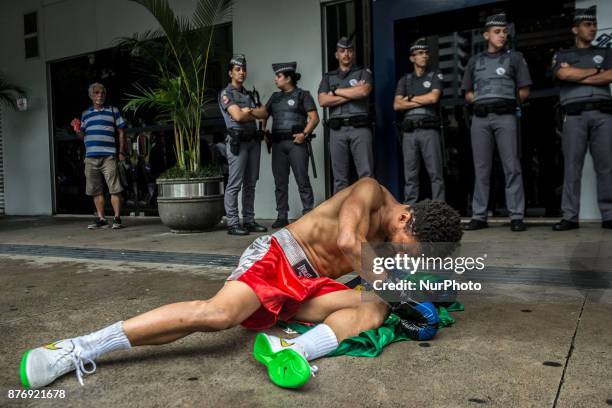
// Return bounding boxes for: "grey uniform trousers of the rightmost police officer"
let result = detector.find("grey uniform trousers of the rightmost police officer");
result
[561,110,612,221]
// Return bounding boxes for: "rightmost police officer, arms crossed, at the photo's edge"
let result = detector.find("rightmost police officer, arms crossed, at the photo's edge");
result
[553,6,612,231]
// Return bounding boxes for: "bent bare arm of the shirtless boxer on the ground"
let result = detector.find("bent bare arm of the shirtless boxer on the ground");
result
[336,177,384,282]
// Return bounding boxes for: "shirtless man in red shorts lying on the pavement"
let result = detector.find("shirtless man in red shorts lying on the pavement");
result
[20,178,461,388]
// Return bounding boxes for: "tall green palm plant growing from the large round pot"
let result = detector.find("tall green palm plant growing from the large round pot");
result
[119,0,233,172]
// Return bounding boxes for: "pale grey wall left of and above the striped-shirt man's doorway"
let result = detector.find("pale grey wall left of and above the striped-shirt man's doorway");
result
[0,0,195,215]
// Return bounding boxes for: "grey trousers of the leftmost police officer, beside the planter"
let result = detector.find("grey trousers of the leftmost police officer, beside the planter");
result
[224,140,261,227]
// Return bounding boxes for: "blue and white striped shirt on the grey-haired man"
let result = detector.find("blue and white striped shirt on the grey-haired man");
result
[81,106,125,157]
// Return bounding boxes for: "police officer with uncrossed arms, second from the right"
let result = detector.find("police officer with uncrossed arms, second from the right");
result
[463,13,531,231]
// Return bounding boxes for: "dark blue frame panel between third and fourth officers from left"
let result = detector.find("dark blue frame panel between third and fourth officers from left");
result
[372,0,496,198]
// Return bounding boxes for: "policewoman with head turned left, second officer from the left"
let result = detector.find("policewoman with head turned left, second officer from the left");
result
[266,62,319,228]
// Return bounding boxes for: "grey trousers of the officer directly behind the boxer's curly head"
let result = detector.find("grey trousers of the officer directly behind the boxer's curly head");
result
[402,129,444,204]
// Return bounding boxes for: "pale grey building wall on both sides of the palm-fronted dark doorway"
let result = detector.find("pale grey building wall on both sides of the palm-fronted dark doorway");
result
[0,0,324,218]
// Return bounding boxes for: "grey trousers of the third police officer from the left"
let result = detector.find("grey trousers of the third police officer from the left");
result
[329,126,374,193]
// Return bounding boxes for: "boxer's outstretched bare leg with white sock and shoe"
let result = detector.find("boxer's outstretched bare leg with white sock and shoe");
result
[20,281,260,388]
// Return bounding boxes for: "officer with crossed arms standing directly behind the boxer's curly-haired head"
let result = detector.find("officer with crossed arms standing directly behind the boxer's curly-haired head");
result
[393,38,444,204]
